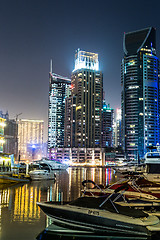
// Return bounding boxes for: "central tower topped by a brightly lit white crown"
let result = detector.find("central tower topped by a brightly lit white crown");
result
[71,49,103,148]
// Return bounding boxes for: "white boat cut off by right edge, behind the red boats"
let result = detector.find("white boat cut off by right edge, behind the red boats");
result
[143,152,160,183]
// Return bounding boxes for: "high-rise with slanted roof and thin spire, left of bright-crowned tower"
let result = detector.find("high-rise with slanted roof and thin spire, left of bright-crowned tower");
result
[48,68,71,150]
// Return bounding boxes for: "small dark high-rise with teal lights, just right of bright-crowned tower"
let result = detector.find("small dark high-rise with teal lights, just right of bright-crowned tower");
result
[102,101,114,147]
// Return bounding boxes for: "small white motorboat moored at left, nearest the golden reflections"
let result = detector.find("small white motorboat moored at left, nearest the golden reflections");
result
[29,162,56,181]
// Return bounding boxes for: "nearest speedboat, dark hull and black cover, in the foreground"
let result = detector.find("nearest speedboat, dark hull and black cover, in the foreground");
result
[37,187,160,236]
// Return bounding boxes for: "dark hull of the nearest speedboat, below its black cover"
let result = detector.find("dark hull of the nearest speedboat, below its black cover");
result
[38,203,160,236]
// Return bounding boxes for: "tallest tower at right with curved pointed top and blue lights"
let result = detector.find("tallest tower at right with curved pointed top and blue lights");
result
[121,27,160,158]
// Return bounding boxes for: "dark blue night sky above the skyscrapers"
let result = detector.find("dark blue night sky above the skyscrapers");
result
[0,0,160,140]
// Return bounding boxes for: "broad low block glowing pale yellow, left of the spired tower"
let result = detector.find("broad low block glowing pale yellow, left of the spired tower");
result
[18,119,44,160]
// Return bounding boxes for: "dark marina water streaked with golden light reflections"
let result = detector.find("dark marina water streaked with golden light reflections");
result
[0,168,152,240]
